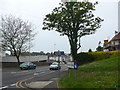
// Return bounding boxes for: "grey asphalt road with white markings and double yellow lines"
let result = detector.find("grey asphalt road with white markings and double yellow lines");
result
[0,65,67,89]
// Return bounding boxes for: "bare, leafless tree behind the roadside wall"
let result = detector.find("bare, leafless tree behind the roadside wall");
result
[0,15,35,64]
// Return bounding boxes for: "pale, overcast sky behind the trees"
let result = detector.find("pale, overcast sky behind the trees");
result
[0,0,118,53]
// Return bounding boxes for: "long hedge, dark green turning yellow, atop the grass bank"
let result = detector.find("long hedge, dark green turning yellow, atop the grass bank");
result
[77,51,120,65]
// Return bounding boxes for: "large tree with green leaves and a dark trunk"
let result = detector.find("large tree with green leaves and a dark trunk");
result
[43,0,103,61]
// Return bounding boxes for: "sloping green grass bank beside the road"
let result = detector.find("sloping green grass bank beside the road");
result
[59,57,120,88]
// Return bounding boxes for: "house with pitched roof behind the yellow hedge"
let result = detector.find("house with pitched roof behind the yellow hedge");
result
[103,32,120,51]
